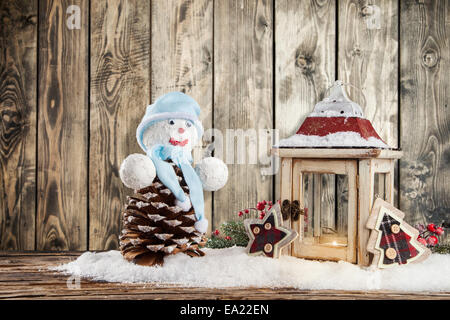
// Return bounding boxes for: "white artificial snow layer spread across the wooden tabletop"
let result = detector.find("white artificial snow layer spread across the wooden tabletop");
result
[51,247,450,291]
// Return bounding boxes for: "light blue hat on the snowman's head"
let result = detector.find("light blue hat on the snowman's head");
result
[136,92,203,152]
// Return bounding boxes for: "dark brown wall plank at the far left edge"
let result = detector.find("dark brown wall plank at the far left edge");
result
[0,0,38,250]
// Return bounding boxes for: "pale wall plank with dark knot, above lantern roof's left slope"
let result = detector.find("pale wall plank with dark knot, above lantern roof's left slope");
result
[274,0,336,204]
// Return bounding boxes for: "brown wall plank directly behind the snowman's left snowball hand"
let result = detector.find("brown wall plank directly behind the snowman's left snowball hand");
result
[89,0,150,250]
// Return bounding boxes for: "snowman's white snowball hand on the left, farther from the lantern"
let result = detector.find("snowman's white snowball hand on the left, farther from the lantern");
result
[119,153,156,190]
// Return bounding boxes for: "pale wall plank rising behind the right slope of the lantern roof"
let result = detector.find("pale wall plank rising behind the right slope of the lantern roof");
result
[338,0,398,148]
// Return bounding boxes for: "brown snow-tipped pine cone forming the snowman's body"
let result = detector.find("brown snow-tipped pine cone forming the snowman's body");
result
[119,163,206,266]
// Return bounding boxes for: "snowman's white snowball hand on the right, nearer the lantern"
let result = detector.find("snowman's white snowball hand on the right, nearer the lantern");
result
[195,157,228,191]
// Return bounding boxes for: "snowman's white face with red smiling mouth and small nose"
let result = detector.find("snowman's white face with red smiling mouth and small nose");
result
[143,119,198,152]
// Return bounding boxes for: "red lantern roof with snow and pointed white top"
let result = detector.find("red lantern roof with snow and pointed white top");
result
[276,80,389,149]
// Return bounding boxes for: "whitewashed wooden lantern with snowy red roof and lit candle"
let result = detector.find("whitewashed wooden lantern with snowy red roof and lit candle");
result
[273,82,402,266]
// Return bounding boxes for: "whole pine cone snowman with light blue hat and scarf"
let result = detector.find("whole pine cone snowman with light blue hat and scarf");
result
[119,92,228,265]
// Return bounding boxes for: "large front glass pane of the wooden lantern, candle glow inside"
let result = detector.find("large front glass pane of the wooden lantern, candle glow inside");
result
[302,172,348,246]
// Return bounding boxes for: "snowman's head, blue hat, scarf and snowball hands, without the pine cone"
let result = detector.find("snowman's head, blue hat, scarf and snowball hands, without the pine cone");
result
[119,92,228,233]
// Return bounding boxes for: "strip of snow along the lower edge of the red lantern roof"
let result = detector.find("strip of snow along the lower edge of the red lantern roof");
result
[275,131,389,149]
